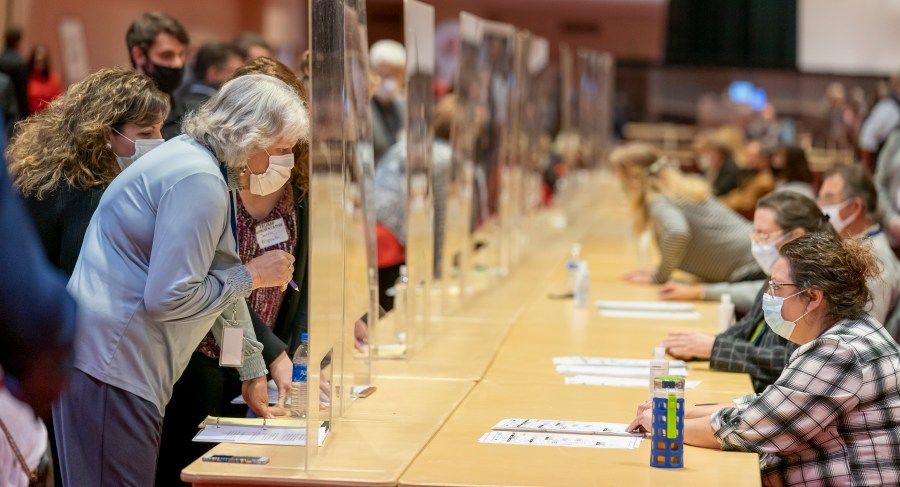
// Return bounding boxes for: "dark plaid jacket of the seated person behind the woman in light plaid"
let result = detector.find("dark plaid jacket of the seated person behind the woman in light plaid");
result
[709,281,797,392]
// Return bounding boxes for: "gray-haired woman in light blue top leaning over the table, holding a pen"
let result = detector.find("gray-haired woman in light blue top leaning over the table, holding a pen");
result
[53,75,309,485]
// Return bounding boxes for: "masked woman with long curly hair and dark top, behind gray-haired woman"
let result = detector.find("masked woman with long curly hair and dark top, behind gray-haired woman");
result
[6,69,169,275]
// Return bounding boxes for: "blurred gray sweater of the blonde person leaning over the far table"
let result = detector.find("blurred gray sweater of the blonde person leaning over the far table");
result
[648,197,762,283]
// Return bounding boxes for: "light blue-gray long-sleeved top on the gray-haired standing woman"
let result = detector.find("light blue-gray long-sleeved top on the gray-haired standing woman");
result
[68,135,266,414]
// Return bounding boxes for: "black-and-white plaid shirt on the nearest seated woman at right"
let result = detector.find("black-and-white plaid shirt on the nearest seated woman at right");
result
[711,316,900,486]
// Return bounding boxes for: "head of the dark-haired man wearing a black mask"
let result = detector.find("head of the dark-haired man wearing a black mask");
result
[125,12,190,140]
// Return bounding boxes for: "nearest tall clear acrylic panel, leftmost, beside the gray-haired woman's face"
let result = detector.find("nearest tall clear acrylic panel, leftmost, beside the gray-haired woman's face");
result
[304,0,346,470]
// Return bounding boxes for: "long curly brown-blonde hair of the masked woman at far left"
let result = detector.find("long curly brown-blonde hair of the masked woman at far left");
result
[6,68,169,199]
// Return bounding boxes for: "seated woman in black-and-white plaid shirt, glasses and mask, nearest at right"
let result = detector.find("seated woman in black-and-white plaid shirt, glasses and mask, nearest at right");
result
[631,233,900,486]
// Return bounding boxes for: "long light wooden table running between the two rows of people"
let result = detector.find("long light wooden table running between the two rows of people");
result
[182,178,760,486]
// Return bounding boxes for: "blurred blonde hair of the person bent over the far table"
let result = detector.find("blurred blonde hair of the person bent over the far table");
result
[610,142,712,233]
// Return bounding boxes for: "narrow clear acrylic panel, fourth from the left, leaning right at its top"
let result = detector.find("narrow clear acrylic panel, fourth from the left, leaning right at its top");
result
[438,12,487,314]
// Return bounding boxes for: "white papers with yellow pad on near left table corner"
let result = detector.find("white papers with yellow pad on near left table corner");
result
[194,418,329,446]
